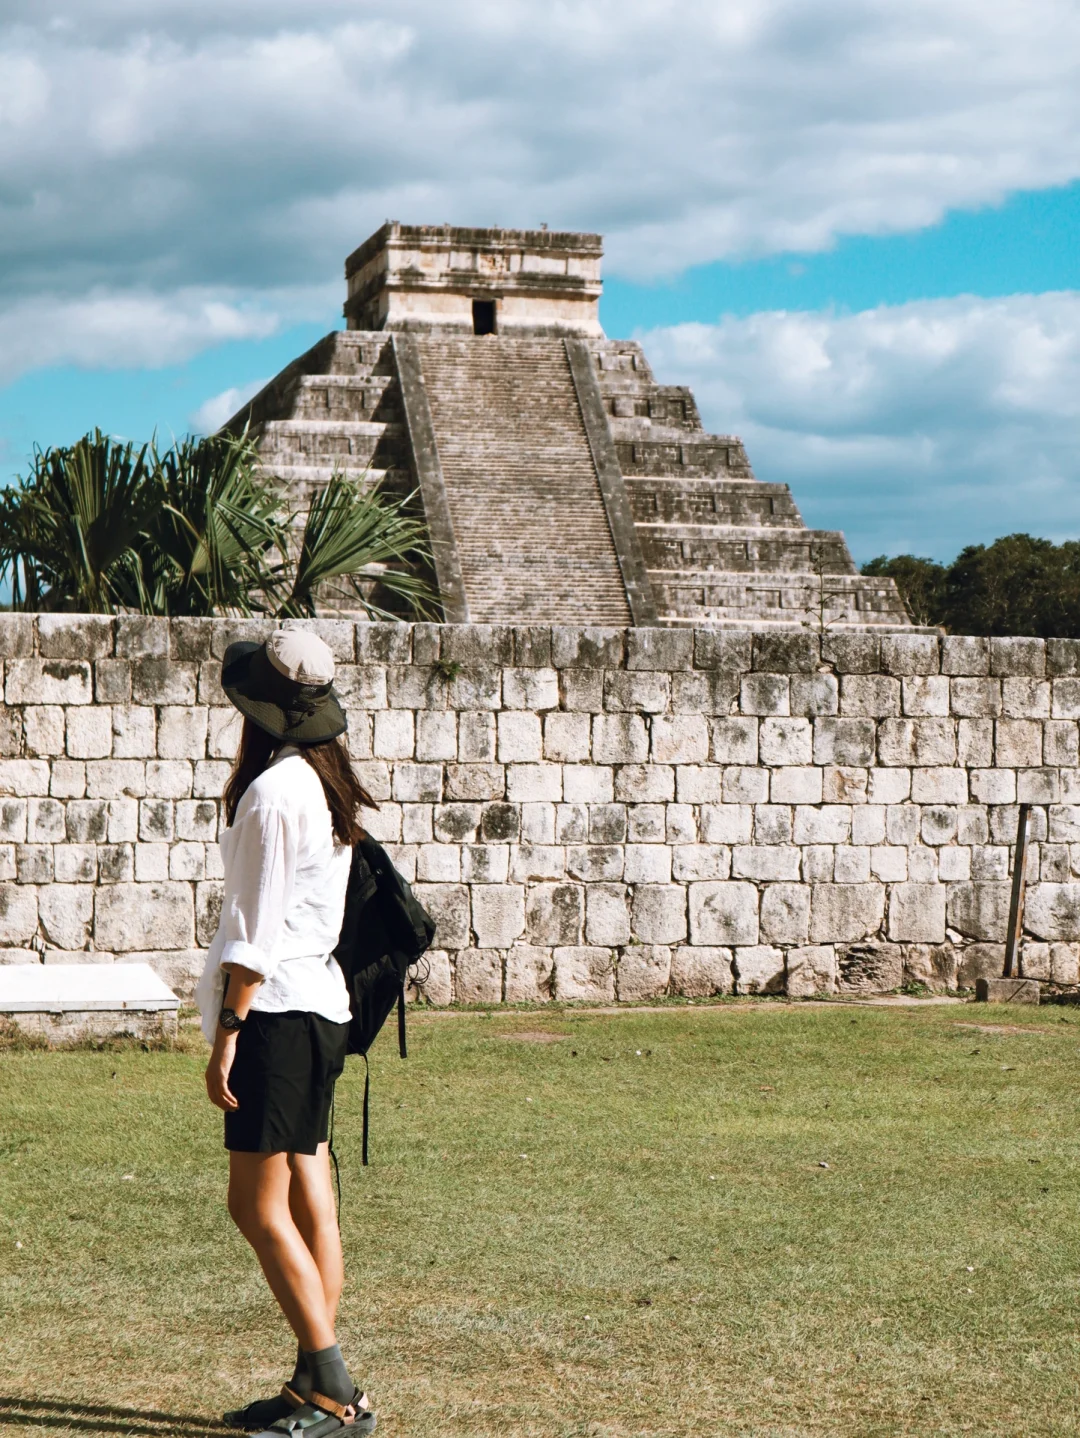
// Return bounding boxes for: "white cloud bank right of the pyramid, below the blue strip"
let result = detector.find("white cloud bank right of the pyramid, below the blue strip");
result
[640,292,1080,559]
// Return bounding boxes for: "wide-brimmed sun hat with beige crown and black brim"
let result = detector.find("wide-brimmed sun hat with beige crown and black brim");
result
[221,628,348,745]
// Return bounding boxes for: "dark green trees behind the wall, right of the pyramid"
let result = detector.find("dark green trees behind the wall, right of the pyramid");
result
[861,535,1080,638]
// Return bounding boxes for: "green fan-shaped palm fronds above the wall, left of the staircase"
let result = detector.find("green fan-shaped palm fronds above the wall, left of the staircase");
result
[0,430,437,618]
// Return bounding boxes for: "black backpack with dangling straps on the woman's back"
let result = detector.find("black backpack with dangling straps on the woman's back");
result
[334,837,434,1163]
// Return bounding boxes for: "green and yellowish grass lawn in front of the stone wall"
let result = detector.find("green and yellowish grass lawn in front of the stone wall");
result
[0,1004,1080,1438]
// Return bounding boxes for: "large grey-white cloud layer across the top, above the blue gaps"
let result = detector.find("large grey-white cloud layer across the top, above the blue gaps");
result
[0,0,1080,340]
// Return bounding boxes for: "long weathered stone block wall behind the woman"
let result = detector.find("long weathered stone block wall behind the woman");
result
[0,615,1080,1004]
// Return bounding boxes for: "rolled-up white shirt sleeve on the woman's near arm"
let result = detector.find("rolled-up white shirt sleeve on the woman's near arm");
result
[220,804,296,979]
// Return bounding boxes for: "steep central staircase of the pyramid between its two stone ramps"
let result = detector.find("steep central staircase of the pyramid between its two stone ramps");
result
[417,336,630,624]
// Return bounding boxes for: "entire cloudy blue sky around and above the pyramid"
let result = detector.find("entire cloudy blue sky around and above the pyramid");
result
[0,0,1080,561]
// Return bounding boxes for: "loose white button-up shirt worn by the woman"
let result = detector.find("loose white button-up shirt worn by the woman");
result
[196,746,352,1043]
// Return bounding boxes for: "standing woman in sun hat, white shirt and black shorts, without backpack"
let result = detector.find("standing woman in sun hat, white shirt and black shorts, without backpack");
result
[197,630,375,1438]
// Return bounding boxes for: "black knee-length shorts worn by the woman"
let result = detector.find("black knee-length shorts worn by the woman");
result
[224,1009,349,1153]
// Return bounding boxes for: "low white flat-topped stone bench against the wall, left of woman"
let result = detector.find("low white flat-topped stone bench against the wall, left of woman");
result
[0,963,180,1040]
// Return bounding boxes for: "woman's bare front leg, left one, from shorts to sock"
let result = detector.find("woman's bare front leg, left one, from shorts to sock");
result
[229,1153,337,1352]
